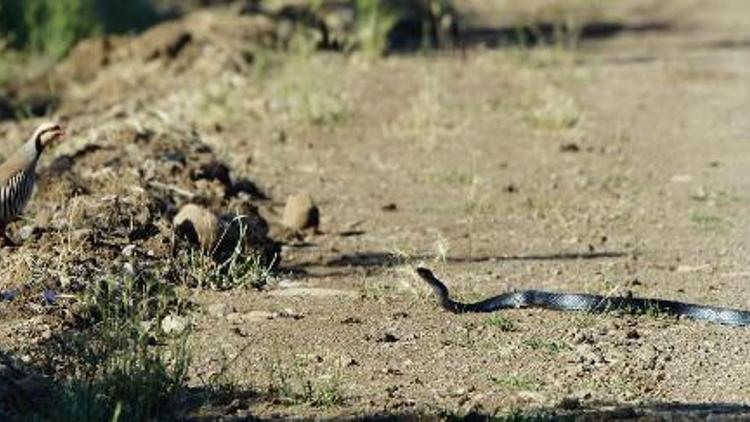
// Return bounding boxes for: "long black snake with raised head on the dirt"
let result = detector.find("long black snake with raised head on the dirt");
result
[416,267,750,326]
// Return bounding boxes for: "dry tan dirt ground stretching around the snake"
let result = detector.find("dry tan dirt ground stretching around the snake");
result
[0,0,750,419]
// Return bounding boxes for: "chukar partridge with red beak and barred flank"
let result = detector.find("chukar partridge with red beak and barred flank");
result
[0,123,65,244]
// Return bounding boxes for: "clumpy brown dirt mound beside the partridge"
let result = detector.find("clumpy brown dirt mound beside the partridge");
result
[0,118,279,310]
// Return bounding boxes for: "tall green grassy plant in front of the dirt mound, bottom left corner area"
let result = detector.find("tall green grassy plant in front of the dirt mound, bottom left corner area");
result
[34,276,190,421]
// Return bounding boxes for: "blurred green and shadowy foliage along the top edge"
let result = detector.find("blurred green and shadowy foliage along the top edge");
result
[0,0,455,60]
